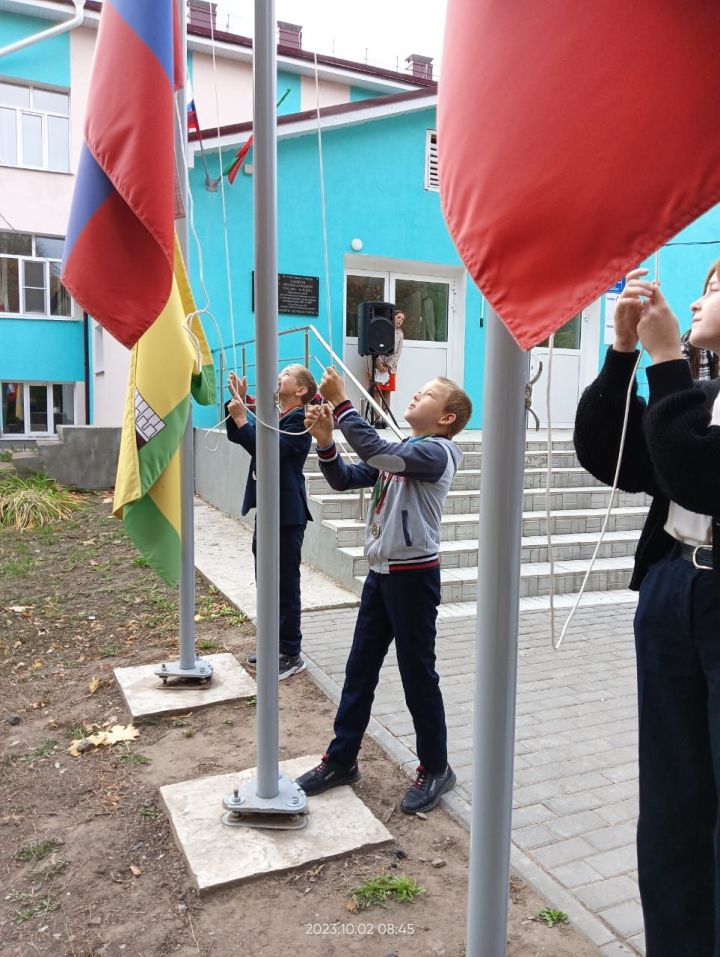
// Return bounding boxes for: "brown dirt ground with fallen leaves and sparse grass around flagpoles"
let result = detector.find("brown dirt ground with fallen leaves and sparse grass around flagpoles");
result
[0,494,597,957]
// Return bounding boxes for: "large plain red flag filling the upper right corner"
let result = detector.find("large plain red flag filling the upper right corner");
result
[438,0,720,348]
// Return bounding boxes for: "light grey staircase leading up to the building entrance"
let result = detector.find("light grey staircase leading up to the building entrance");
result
[303,432,649,613]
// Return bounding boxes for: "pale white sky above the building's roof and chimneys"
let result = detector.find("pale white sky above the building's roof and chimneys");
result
[217,0,446,77]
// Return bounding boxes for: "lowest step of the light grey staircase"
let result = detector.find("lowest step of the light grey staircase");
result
[354,556,634,602]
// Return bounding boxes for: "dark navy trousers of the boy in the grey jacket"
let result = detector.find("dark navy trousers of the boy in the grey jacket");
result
[328,568,447,774]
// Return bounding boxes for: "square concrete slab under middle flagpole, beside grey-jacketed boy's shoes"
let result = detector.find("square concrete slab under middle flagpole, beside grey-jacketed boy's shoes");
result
[160,755,393,893]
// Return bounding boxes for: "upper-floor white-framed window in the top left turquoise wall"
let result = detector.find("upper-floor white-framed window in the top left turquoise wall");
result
[0,83,70,173]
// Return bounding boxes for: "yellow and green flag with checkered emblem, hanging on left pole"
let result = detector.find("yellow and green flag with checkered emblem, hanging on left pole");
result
[113,237,215,585]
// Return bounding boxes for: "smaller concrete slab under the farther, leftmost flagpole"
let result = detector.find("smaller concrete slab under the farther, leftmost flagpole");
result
[114,653,256,718]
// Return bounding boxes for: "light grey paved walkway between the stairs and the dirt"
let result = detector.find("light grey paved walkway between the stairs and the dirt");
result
[196,506,645,957]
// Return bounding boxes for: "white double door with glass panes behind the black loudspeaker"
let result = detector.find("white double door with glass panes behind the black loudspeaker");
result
[343,268,462,425]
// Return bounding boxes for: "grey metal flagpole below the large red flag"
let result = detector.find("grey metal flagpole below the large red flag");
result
[467,306,529,957]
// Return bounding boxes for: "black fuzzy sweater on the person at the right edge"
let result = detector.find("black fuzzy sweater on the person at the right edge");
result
[574,348,720,591]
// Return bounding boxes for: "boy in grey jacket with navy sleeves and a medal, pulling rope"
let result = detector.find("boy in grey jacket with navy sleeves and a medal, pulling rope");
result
[297,369,472,814]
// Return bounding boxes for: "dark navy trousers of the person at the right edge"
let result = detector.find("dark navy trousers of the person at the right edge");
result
[635,549,720,957]
